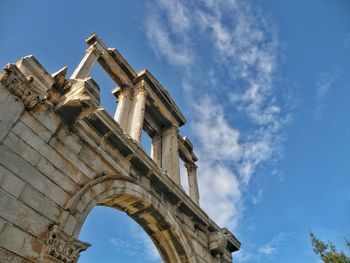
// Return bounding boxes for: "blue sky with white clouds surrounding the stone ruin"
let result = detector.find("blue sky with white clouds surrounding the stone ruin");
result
[0,0,350,263]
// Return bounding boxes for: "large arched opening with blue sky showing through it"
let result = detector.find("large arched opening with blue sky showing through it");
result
[78,206,161,263]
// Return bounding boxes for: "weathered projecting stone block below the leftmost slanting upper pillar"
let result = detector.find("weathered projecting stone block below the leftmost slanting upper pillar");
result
[56,78,100,125]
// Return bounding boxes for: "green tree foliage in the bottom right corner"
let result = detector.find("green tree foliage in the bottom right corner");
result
[310,231,350,263]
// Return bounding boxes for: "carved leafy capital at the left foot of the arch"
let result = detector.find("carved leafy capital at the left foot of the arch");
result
[44,225,91,263]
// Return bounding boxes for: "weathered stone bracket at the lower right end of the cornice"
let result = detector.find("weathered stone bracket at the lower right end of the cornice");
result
[209,228,241,263]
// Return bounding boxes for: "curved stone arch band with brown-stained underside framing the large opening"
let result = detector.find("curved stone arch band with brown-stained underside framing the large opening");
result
[55,175,197,262]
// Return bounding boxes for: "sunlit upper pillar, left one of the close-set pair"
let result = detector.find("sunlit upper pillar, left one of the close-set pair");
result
[114,87,132,132]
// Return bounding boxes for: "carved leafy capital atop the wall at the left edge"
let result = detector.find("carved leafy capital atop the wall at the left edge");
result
[0,64,46,110]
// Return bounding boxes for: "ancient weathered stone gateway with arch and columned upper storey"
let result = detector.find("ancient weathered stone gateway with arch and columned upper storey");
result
[0,34,240,263]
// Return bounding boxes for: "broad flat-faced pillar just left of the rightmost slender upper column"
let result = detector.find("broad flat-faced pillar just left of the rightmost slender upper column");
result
[162,126,181,185]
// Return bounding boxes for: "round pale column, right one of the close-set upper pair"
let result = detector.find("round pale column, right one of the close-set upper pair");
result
[130,83,148,142]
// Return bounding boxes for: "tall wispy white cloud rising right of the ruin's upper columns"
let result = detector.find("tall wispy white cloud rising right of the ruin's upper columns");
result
[145,0,288,231]
